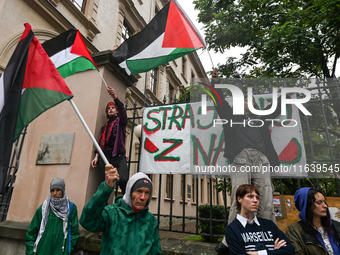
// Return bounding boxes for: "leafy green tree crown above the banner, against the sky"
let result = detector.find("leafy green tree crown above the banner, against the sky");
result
[194,0,340,78]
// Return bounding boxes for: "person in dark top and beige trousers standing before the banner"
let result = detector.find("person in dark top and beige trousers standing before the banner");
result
[212,69,289,223]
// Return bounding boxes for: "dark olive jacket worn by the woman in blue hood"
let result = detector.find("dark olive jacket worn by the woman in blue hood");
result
[286,220,340,255]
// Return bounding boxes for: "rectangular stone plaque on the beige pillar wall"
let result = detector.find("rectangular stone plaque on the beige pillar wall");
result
[36,132,75,165]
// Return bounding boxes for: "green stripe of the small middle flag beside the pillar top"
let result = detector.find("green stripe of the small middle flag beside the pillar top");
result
[57,57,97,78]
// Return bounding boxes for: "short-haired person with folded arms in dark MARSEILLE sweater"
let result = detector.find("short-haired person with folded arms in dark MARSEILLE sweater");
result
[225,184,294,255]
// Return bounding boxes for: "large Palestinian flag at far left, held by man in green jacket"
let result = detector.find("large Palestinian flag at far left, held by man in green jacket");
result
[0,24,72,194]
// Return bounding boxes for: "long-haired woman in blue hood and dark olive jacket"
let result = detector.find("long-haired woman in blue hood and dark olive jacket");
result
[286,188,340,255]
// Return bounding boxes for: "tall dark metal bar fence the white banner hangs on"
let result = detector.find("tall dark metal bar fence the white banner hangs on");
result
[126,79,340,237]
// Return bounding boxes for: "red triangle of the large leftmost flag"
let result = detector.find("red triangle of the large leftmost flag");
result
[22,37,72,96]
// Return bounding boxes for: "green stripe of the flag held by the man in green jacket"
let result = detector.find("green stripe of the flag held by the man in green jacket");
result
[14,88,72,141]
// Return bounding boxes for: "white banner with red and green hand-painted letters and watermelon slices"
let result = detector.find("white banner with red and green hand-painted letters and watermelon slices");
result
[140,94,306,177]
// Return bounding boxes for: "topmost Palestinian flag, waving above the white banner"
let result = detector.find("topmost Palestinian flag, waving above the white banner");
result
[113,0,205,74]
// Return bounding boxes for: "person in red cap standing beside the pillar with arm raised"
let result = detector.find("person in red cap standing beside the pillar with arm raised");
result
[91,84,129,195]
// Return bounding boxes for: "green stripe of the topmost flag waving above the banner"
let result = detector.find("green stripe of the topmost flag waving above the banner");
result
[126,48,196,75]
